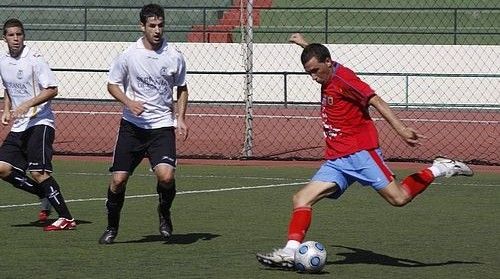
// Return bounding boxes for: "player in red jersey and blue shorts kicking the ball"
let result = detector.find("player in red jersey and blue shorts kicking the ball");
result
[257,33,473,269]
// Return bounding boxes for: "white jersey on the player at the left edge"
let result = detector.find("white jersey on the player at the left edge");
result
[0,46,57,132]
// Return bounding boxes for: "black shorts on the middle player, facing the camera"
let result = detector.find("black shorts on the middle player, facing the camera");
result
[109,119,177,174]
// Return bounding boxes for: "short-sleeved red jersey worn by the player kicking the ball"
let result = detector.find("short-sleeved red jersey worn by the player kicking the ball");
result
[321,63,379,160]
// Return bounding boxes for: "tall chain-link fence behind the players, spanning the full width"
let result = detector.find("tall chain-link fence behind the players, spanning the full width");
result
[0,0,500,165]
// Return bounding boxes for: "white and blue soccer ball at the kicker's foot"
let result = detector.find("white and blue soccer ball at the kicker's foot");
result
[294,241,326,273]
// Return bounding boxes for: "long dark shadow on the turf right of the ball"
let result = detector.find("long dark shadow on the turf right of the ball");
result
[327,245,482,267]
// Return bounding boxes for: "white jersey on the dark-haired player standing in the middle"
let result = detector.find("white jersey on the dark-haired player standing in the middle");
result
[108,38,186,129]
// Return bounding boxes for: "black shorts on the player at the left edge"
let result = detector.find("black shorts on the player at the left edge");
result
[0,125,55,172]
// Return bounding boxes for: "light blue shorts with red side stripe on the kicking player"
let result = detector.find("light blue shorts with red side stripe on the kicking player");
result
[311,148,394,199]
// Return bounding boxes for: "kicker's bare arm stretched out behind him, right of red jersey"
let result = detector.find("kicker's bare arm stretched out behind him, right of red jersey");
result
[370,95,425,146]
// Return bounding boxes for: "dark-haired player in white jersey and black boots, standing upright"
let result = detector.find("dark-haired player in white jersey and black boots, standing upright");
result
[99,4,188,244]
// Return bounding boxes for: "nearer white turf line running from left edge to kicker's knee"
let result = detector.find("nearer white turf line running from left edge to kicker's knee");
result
[0,181,307,209]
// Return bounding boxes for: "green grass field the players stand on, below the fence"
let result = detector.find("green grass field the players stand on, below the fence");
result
[0,160,500,278]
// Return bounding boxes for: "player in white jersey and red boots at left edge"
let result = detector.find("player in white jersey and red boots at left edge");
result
[0,19,76,231]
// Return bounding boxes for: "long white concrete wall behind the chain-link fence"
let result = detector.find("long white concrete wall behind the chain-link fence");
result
[2,41,500,105]
